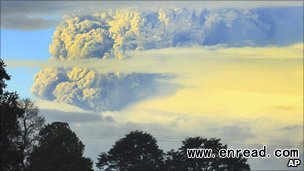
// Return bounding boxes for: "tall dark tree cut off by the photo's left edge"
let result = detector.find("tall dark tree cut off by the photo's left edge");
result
[0,59,23,170]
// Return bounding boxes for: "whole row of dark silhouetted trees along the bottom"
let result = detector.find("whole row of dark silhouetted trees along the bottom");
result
[0,59,250,171]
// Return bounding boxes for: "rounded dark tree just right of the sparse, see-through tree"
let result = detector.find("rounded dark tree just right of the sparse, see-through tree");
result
[28,122,92,171]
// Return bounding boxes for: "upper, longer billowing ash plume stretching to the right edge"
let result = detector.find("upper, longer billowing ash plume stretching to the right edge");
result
[50,7,303,60]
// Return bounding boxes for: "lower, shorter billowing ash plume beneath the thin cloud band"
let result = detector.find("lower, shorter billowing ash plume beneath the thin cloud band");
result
[32,67,173,111]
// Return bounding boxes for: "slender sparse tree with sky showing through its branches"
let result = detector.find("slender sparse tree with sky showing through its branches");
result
[18,99,45,170]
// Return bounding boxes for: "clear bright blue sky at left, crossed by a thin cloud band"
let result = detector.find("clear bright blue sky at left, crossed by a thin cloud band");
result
[1,28,55,98]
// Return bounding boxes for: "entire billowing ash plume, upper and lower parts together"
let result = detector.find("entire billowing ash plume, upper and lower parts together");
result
[32,7,303,111]
